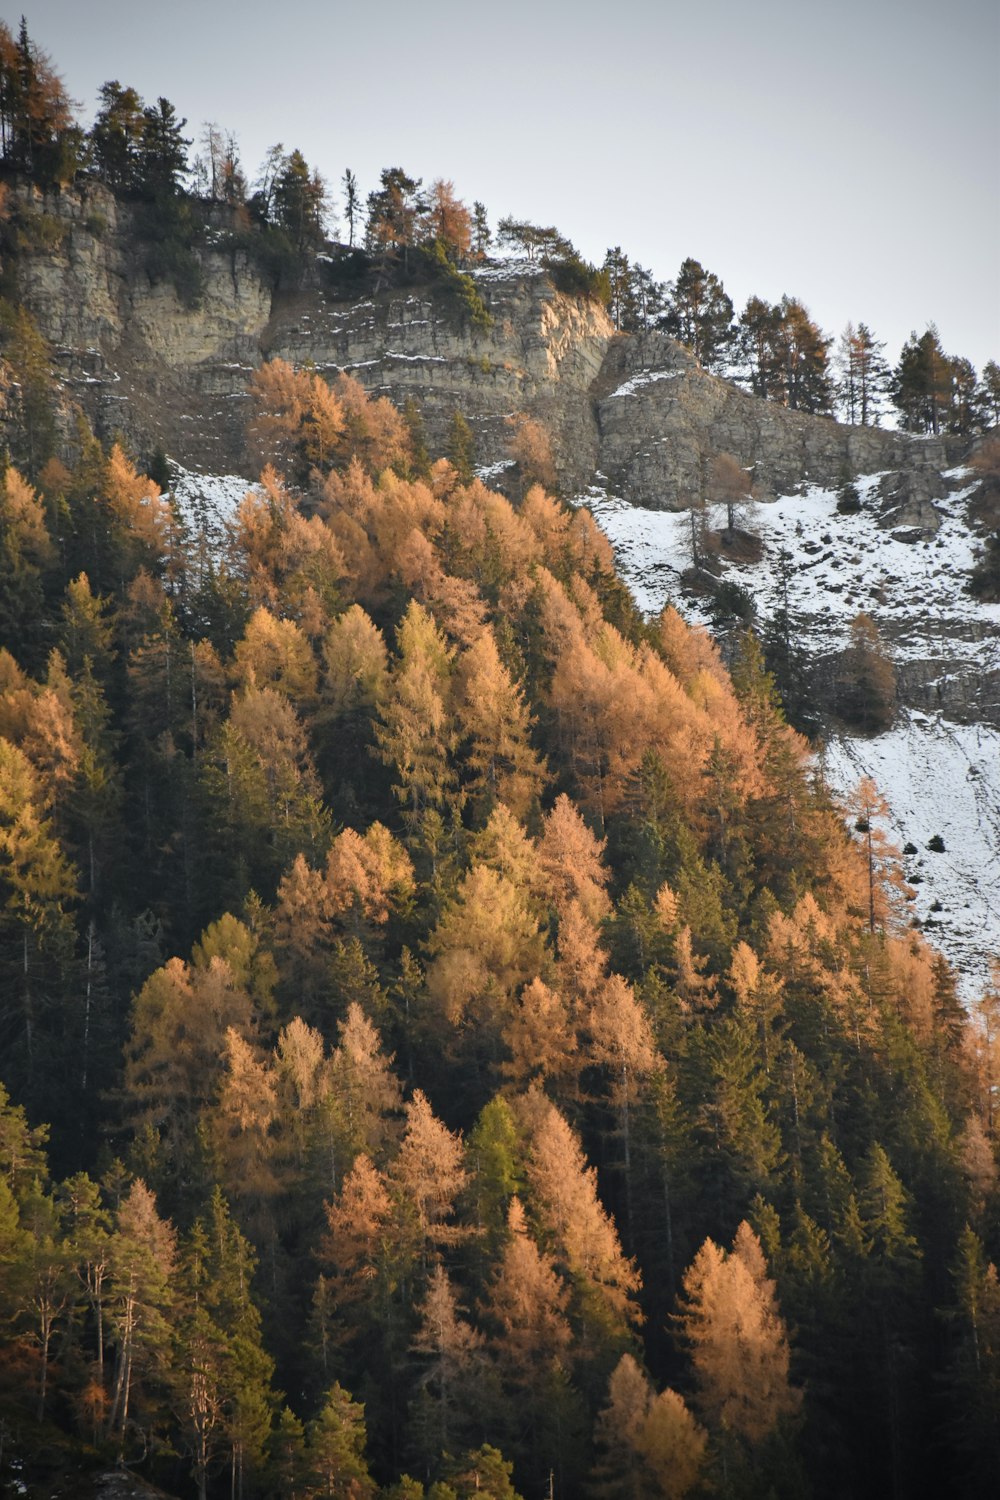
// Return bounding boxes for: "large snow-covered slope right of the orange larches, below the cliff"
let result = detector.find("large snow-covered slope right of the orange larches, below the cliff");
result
[580,473,1000,999]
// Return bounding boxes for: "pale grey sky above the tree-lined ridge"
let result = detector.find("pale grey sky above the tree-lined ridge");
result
[21,0,1000,371]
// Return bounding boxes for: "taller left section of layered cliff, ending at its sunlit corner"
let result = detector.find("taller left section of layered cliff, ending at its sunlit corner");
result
[16,185,613,488]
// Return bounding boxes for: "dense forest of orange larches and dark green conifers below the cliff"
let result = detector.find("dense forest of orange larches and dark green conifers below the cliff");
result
[0,17,1000,1500]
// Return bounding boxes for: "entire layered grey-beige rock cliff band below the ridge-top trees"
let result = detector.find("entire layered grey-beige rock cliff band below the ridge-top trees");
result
[5,185,955,510]
